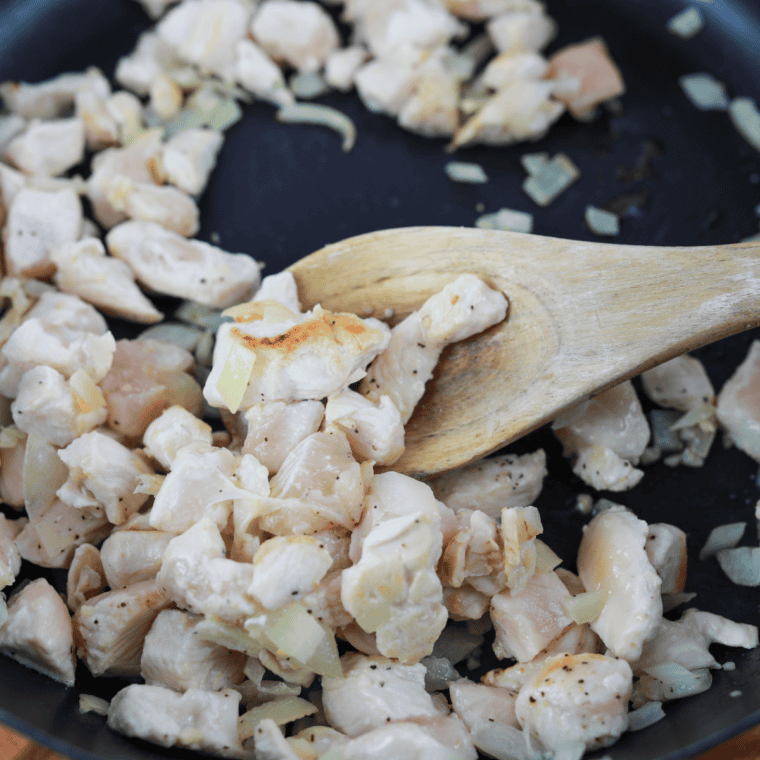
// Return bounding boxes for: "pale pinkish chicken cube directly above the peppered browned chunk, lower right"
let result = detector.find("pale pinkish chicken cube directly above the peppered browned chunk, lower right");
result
[491,572,573,662]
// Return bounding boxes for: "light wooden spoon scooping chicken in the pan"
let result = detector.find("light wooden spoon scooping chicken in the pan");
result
[290,227,760,476]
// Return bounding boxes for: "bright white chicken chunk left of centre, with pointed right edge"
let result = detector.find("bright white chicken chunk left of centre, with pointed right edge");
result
[150,444,250,533]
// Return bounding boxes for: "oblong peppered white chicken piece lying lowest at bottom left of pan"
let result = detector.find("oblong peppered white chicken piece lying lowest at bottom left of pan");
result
[108,684,245,758]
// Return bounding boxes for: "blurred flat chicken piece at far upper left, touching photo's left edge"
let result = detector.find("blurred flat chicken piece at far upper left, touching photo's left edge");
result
[0,68,111,119]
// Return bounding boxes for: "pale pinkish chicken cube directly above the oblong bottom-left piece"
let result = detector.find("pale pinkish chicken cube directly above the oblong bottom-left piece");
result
[140,610,247,692]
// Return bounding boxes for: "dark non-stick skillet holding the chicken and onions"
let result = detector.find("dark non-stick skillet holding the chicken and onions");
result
[0,0,760,760]
